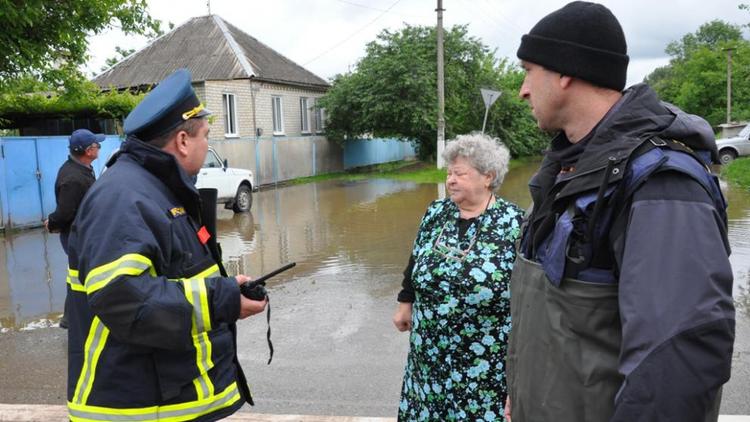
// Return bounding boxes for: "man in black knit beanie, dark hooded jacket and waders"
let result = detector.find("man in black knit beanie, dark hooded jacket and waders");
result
[506,1,734,422]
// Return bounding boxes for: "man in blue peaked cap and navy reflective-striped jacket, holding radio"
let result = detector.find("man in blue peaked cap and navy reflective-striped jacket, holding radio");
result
[67,70,266,421]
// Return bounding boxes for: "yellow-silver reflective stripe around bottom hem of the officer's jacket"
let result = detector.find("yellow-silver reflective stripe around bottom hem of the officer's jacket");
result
[68,382,241,422]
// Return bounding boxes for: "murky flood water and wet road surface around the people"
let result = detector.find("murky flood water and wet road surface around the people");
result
[0,159,750,416]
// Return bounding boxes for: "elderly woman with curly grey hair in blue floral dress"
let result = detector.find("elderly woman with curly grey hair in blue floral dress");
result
[393,134,523,421]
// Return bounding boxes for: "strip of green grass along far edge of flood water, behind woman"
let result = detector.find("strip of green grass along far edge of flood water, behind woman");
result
[288,157,539,185]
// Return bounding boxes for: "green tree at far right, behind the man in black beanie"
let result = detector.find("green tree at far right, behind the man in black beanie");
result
[646,20,750,125]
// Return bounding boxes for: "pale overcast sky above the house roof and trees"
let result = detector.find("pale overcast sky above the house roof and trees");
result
[86,0,750,85]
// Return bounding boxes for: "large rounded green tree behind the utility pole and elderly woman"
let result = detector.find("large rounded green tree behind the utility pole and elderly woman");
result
[320,25,546,158]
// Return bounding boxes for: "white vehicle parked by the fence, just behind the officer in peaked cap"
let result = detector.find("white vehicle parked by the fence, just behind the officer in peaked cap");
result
[195,147,253,212]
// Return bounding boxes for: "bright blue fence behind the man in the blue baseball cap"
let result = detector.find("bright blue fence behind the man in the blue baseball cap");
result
[0,136,120,228]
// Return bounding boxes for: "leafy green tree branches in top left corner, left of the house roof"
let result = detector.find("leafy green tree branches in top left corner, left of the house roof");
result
[0,0,160,89]
